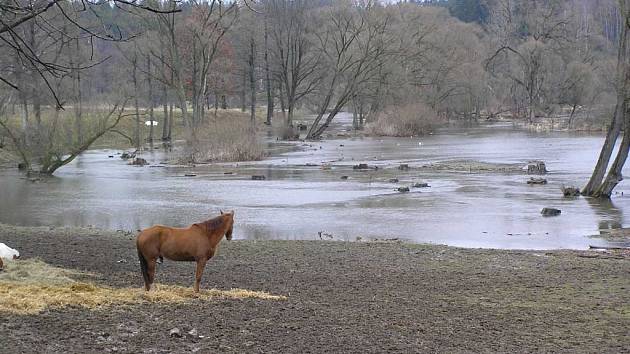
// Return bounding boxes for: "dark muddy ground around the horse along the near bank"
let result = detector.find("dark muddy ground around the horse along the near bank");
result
[0,225,630,353]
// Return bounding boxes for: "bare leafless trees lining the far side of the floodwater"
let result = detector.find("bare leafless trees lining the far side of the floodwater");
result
[0,0,625,185]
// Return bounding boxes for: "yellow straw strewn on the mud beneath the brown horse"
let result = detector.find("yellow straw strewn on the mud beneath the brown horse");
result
[0,260,286,314]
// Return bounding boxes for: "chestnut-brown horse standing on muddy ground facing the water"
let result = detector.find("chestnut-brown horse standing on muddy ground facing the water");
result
[136,211,234,292]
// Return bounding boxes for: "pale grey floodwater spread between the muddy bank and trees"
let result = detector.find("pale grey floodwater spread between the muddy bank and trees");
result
[0,115,630,249]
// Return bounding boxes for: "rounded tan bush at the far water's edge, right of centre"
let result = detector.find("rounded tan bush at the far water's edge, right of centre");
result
[366,103,438,136]
